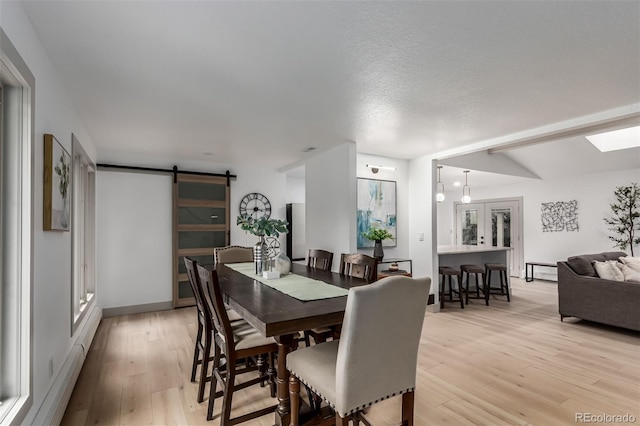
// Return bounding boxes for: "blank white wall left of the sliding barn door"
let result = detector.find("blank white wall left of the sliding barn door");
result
[97,170,173,309]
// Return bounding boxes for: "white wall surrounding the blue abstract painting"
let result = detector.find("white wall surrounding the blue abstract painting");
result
[353,154,409,260]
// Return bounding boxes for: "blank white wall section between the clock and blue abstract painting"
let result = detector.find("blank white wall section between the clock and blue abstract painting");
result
[305,143,356,271]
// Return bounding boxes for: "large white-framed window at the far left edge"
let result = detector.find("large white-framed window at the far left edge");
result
[0,30,35,424]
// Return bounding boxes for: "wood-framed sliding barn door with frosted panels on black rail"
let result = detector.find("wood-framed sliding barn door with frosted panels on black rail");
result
[173,174,230,308]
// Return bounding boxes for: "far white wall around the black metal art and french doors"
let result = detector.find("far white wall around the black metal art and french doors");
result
[438,165,640,278]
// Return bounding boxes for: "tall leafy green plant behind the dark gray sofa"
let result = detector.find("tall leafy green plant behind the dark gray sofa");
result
[604,183,640,256]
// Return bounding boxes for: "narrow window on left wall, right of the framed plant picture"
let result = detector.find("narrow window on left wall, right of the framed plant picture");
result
[71,135,96,335]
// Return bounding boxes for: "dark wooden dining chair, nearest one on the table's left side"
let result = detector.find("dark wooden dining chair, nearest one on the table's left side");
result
[198,266,278,426]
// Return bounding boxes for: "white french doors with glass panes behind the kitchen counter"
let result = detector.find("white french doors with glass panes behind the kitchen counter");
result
[455,199,523,276]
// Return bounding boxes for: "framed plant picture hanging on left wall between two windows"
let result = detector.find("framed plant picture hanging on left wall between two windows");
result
[43,134,71,231]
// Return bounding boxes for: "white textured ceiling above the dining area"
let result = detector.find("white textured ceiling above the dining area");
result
[22,0,640,174]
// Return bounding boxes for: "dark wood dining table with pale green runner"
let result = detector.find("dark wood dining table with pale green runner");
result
[214,264,367,426]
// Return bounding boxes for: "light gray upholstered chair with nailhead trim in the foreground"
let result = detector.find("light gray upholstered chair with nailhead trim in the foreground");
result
[287,276,431,425]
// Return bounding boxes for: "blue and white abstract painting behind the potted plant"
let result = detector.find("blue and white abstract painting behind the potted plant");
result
[357,178,397,248]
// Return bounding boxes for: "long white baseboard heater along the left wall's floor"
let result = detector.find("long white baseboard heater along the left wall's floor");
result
[33,305,102,425]
